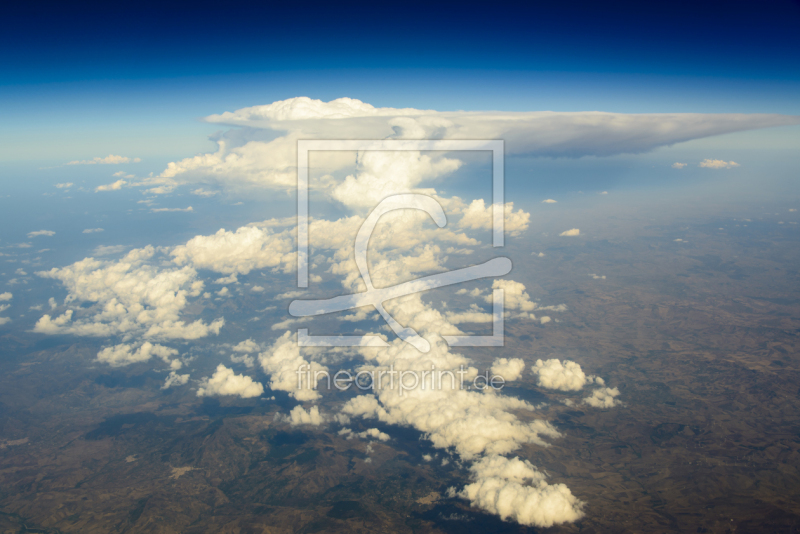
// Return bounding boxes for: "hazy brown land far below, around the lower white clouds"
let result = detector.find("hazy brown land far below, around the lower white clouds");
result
[0,208,800,533]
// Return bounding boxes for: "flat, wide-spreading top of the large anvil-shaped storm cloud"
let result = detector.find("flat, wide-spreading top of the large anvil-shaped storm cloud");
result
[205,97,800,157]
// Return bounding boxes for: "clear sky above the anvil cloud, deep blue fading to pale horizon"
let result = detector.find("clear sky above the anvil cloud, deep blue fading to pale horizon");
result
[0,0,800,167]
